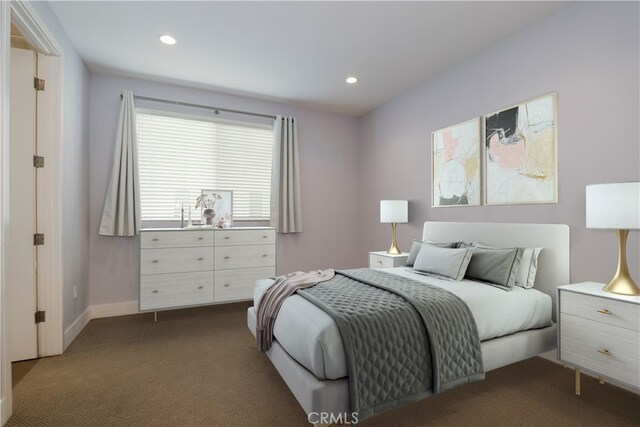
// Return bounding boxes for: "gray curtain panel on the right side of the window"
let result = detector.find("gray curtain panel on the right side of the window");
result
[271,116,302,233]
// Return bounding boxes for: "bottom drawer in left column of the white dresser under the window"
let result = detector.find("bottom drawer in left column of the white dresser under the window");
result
[140,271,213,310]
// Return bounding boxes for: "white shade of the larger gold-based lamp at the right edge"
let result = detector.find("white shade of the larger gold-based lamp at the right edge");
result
[586,182,640,230]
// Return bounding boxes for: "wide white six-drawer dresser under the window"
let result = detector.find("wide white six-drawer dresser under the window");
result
[140,227,276,311]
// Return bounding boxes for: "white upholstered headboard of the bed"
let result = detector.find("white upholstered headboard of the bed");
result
[422,221,570,319]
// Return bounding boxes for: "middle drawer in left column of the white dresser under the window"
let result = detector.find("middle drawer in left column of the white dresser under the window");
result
[140,247,213,275]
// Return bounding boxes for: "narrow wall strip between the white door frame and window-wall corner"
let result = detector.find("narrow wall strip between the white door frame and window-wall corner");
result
[31,2,90,329]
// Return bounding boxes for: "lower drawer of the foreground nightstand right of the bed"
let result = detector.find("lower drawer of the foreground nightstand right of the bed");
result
[560,313,640,387]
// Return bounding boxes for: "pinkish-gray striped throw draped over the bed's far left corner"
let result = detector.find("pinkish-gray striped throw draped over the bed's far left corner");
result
[256,269,335,351]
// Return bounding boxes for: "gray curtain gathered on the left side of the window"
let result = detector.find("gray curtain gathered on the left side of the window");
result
[100,90,141,236]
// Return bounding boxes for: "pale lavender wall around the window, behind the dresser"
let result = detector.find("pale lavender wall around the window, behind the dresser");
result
[90,74,361,305]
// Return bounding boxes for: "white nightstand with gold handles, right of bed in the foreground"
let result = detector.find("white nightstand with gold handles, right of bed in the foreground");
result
[558,282,640,395]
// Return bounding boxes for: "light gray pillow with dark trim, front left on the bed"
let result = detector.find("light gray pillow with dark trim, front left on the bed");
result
[413,244,475,280]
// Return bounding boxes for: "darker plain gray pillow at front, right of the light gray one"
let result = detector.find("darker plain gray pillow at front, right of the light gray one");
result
[464,245,523,289]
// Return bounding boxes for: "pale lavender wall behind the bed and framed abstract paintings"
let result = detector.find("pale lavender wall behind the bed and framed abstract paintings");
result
[359,2,640,288]
